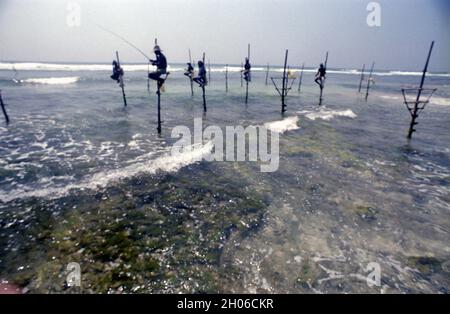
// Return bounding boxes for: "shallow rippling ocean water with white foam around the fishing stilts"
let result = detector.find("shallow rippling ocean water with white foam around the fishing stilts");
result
[0,65,450,293]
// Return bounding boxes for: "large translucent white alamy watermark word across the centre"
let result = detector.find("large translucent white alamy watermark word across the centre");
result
[171,118,280,172]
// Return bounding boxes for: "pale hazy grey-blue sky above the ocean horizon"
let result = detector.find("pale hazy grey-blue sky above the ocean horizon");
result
[0,0,450,71]
